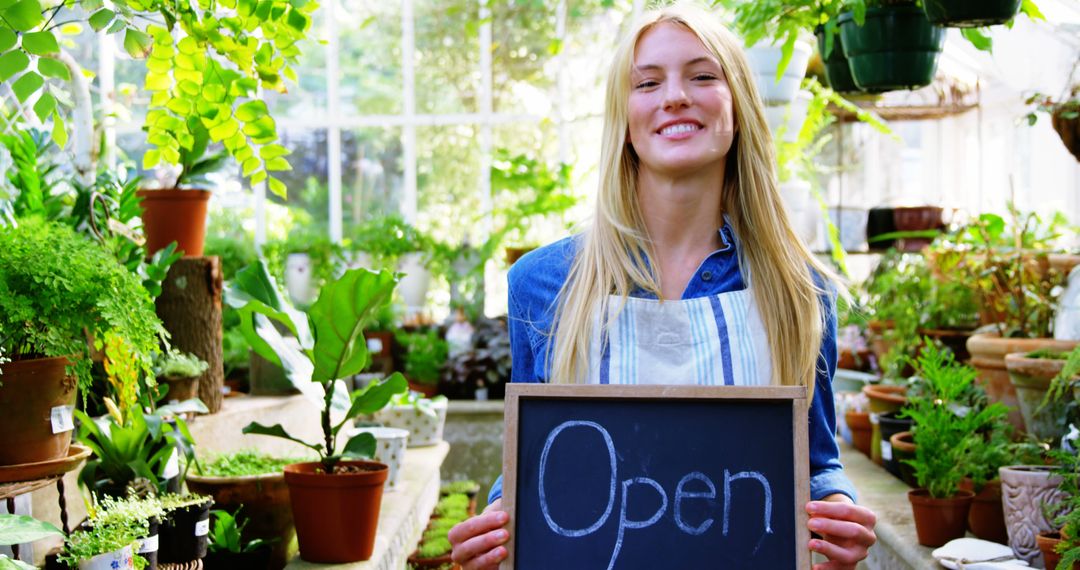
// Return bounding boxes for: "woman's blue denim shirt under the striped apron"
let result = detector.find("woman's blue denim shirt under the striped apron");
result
[488,223,855,503]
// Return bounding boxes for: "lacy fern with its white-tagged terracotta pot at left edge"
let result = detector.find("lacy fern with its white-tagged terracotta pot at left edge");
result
[0,219,164,465]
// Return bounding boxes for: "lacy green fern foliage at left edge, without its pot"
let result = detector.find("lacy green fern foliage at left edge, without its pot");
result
[0,219,165,407]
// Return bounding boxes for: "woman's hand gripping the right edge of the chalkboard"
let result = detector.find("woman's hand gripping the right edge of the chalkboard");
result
[807,494,877,570]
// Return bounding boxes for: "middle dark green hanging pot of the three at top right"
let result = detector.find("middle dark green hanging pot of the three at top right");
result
[838,6,945,93]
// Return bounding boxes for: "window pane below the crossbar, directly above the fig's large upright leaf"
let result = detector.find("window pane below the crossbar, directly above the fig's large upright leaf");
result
[341,128,405,226]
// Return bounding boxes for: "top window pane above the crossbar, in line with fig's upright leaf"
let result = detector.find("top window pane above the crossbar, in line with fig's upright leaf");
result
[337,0,403,114]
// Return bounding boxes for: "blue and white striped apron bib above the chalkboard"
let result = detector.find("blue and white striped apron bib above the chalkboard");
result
[590,289,772,385]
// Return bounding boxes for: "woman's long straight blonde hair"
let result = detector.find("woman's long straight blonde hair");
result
[548,5,843,397]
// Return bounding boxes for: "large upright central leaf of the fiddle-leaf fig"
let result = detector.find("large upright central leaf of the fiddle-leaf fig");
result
[308,269,397,382]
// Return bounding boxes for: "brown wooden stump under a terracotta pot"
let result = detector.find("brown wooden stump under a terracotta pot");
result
[157,256,225,413]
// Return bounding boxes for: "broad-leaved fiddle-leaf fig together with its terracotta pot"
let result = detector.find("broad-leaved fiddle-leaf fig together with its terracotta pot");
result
[230,263,408,562]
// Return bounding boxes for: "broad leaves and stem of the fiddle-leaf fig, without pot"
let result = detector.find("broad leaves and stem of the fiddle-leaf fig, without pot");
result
[227,262,408,474]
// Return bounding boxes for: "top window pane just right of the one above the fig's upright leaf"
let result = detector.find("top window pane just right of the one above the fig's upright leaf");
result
[413,0,481,114]
